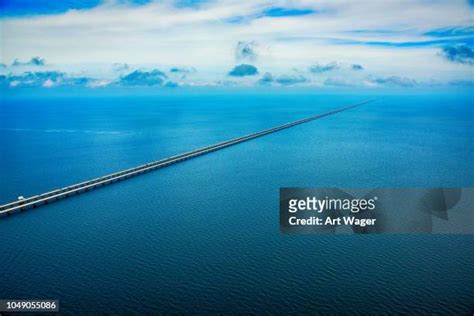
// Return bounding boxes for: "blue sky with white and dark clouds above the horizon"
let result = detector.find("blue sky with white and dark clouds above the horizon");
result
[0,0,474,89]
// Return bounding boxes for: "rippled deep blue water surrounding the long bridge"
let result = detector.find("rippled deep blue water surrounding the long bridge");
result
[0,92,474,315]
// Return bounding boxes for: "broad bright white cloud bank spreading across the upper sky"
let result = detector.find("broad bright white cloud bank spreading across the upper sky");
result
[0,0,474,86]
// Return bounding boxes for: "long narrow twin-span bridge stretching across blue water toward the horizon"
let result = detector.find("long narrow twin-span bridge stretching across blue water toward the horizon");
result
[0,99,375,215]
